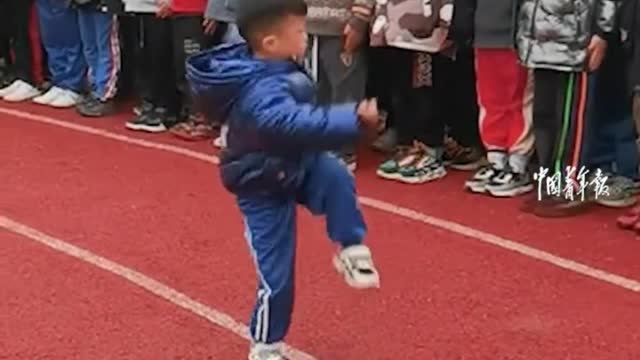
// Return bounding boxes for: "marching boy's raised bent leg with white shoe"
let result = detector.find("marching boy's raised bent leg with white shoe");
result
[298,153,380,289]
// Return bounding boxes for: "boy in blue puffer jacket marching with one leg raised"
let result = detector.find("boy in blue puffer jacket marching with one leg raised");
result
[187,0,379,360]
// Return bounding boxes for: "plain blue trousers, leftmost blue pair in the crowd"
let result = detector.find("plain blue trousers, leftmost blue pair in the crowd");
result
[36,0,87,92]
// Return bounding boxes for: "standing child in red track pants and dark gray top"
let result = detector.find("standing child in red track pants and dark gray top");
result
[465,0,534,197]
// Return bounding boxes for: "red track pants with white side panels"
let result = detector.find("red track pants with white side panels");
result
[476,49,534,156]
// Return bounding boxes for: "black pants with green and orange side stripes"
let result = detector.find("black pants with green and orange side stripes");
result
[533,70,589,175]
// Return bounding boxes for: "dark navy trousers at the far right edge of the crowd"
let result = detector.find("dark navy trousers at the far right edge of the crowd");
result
[584,43,639,179]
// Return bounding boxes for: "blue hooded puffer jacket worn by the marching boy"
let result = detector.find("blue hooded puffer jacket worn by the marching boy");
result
[187,44,359,195]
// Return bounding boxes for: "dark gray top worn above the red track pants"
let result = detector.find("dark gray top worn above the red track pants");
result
[474,0,517,49]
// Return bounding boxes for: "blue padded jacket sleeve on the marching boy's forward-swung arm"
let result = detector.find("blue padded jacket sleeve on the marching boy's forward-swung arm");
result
[238,77,359,150]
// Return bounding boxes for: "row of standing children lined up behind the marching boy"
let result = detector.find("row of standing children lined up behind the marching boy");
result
[0,0,640,207]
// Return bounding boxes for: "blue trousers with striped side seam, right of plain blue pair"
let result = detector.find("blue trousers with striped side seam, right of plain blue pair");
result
[78,7,120,101]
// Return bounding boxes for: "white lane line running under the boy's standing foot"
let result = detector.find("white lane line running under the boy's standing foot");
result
[0,215,316,360]
